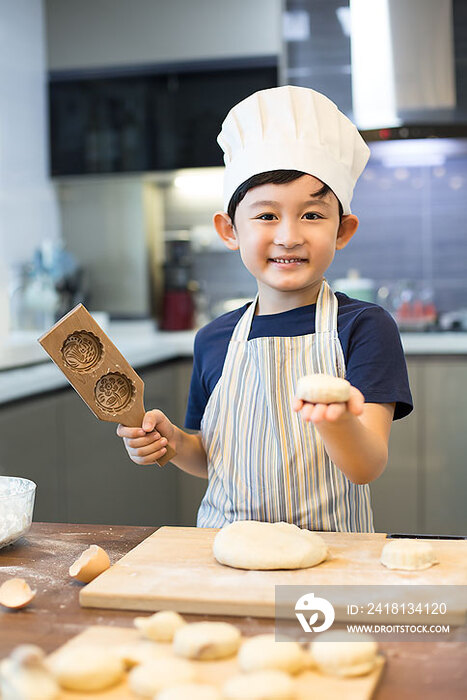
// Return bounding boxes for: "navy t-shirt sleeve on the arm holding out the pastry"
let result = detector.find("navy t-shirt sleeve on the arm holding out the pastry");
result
[346,305,413,420]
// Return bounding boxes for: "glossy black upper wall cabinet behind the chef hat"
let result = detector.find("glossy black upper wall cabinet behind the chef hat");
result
[49,61,277,175]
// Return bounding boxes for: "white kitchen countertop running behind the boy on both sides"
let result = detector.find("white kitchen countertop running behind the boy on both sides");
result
[0,321,467,404]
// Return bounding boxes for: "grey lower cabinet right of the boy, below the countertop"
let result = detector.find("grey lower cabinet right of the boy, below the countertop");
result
[370,355,467,535]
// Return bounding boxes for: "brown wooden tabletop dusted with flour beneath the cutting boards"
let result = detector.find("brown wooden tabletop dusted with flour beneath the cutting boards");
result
[0,523,467,700]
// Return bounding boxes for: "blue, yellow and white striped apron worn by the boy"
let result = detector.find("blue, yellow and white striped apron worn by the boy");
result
[197,280,373,532]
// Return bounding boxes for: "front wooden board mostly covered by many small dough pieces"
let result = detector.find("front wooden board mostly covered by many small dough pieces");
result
[46,626,384,700]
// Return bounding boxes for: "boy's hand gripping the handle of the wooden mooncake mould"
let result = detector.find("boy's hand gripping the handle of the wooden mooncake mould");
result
[117,409,175,464]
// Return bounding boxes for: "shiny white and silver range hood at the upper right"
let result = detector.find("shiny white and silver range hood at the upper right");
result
[350,0,467,139]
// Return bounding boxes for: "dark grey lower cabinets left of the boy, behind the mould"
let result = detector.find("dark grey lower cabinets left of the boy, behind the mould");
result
[0,360,191,525]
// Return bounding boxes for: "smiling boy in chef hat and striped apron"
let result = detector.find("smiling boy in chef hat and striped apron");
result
[117,86,412,532]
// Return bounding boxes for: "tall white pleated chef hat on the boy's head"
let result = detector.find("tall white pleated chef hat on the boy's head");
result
[217,85,370,214]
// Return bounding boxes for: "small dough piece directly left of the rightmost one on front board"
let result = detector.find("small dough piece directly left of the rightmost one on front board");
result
[238,634,307,673]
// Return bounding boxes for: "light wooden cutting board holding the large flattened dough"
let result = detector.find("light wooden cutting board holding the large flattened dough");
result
[80,527,467,617]
